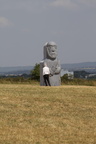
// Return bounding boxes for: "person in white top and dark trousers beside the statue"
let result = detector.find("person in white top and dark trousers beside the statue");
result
[43,64,51,86]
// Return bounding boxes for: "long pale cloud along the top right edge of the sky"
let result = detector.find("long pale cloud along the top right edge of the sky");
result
[50,0,96,9]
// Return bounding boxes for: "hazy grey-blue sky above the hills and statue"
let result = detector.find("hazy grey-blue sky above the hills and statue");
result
[0,0,96,67]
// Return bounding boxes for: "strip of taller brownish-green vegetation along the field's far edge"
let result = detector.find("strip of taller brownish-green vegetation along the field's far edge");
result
[0,77,96,86]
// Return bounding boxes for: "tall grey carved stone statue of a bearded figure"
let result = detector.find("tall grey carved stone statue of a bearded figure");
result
[40,42,61,86]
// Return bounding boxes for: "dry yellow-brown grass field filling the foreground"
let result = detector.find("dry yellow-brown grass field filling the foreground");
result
[0,84,96,144]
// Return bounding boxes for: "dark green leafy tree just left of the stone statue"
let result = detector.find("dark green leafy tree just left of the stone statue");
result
[31,63,40,81]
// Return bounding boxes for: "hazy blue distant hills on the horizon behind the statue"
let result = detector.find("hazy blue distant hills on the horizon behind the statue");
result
[0,62,96,75]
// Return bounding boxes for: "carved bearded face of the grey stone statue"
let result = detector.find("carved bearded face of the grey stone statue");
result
[47,45,57,59]
